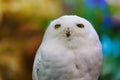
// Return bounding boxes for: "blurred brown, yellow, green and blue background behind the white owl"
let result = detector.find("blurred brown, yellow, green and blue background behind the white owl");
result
[0,0,120,80]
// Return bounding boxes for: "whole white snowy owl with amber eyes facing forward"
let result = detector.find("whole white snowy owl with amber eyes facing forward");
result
[32,15,102,80]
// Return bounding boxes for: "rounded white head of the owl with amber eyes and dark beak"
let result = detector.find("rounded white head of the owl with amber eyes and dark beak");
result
[43,15,98,45]
